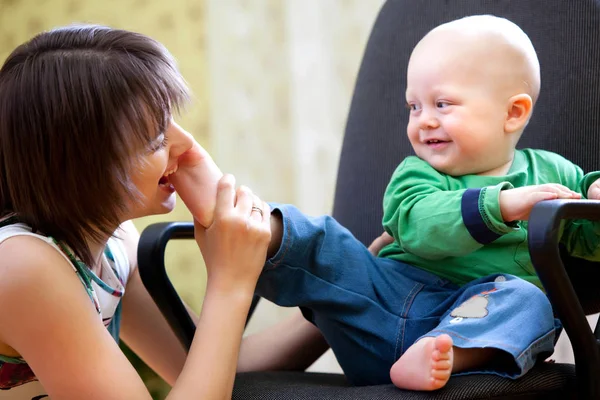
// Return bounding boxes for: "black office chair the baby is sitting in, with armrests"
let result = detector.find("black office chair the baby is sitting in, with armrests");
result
[138,0,600,400]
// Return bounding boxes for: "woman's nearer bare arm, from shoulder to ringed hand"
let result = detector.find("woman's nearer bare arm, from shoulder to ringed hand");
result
[0,177,270,400]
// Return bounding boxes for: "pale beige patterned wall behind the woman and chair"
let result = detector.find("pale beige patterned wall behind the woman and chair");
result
[0,0,382,376]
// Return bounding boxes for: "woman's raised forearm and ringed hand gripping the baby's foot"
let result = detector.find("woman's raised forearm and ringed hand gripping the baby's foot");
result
[172,175,271,399]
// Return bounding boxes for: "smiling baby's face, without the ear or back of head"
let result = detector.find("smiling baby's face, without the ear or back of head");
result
[406,36,514,176]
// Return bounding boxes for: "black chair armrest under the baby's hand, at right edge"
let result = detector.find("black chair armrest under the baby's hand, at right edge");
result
[528,200,600,399]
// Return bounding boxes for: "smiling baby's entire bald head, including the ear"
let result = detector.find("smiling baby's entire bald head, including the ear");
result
[406,15,540,176]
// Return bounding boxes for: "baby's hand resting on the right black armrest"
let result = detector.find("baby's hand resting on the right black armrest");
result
[500,183,581,222]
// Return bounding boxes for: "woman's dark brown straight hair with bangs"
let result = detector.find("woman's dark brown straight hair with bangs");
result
[0,25,188,265]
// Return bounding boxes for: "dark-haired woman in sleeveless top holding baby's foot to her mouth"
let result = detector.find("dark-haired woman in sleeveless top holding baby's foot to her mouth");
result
[0,26,390,400]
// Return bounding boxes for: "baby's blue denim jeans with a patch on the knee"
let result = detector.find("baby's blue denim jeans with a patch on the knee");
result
[257,205,560,385]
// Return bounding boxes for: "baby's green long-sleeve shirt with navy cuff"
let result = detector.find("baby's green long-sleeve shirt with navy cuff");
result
[379,149,600,287]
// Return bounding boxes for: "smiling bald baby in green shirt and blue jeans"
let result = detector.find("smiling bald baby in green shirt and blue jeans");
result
[174,16,600,390]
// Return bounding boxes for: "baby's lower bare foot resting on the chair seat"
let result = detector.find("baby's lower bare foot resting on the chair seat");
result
[390,335,454,390]
